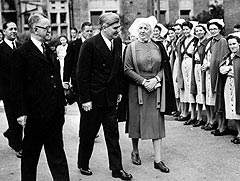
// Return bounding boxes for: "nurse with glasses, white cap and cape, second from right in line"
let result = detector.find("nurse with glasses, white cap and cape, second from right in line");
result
[201,20,228,136]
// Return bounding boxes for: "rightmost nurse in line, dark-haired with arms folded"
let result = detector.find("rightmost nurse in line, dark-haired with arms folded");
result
[219,35,240,144]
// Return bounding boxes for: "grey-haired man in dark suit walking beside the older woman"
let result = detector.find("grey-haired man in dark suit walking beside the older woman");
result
[77,13,132,180]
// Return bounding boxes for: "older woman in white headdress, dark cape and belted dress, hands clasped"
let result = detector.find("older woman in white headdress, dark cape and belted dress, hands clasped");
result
[124,18,176,173]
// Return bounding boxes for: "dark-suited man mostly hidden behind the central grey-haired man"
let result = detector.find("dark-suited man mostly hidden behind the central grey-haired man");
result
[63,22,93,108]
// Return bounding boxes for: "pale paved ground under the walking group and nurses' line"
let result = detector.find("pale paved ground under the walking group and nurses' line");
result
[0,102,240,181]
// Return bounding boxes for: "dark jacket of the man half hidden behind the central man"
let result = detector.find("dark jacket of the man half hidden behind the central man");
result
[63,38,82,94]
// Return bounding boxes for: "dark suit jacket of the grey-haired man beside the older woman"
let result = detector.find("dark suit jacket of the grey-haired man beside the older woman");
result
[77,33,123,106]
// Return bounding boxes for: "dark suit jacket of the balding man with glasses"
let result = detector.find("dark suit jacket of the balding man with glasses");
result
[11,40,65,120]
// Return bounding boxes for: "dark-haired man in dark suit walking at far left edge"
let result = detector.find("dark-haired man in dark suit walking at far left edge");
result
[0,22,22,157]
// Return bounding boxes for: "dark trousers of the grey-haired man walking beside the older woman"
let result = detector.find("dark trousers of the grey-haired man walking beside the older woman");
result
[78,106,122,170]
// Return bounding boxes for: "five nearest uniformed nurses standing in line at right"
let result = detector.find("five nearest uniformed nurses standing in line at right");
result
[169,20,240,144]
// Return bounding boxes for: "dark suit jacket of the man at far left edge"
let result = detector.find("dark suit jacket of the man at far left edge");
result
[0,41,19,99]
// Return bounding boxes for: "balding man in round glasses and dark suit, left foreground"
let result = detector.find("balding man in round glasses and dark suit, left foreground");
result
[11,14,69,181]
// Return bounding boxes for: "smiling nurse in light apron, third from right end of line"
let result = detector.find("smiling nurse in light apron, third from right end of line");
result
[191,25,209,127]
